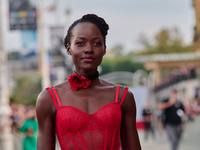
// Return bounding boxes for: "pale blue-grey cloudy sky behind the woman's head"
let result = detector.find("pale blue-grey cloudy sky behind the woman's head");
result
[3,0,195,50]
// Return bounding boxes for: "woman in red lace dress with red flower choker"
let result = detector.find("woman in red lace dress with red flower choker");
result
[36,14,141,150]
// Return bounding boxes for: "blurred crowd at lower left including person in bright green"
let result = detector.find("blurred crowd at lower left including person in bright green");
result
[0,102,38,150]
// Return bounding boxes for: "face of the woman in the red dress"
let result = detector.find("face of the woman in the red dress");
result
[67,22,106,73]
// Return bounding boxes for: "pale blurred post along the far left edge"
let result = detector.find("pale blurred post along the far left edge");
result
[0,0,14,150]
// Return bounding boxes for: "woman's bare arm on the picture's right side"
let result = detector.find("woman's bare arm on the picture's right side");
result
[121,91,141,150]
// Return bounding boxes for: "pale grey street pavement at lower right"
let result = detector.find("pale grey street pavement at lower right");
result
[138,116,200,150]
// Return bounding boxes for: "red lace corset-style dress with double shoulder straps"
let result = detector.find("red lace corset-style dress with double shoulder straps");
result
[47,85,128,150]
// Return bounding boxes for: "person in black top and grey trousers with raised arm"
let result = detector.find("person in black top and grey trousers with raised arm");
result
[157,90,185,150]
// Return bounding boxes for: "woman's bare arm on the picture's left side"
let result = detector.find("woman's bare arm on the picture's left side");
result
[36,90,55,150]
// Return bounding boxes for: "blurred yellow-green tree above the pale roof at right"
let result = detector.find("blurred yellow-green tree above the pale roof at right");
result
[138,27,192,55]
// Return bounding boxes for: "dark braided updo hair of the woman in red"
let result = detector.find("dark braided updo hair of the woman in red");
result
[64,14,109,48]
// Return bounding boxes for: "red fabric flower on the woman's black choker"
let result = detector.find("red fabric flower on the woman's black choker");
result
[68,74,91,91]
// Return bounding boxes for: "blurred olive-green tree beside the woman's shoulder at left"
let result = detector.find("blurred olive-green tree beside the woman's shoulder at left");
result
[10,76,41,105]
